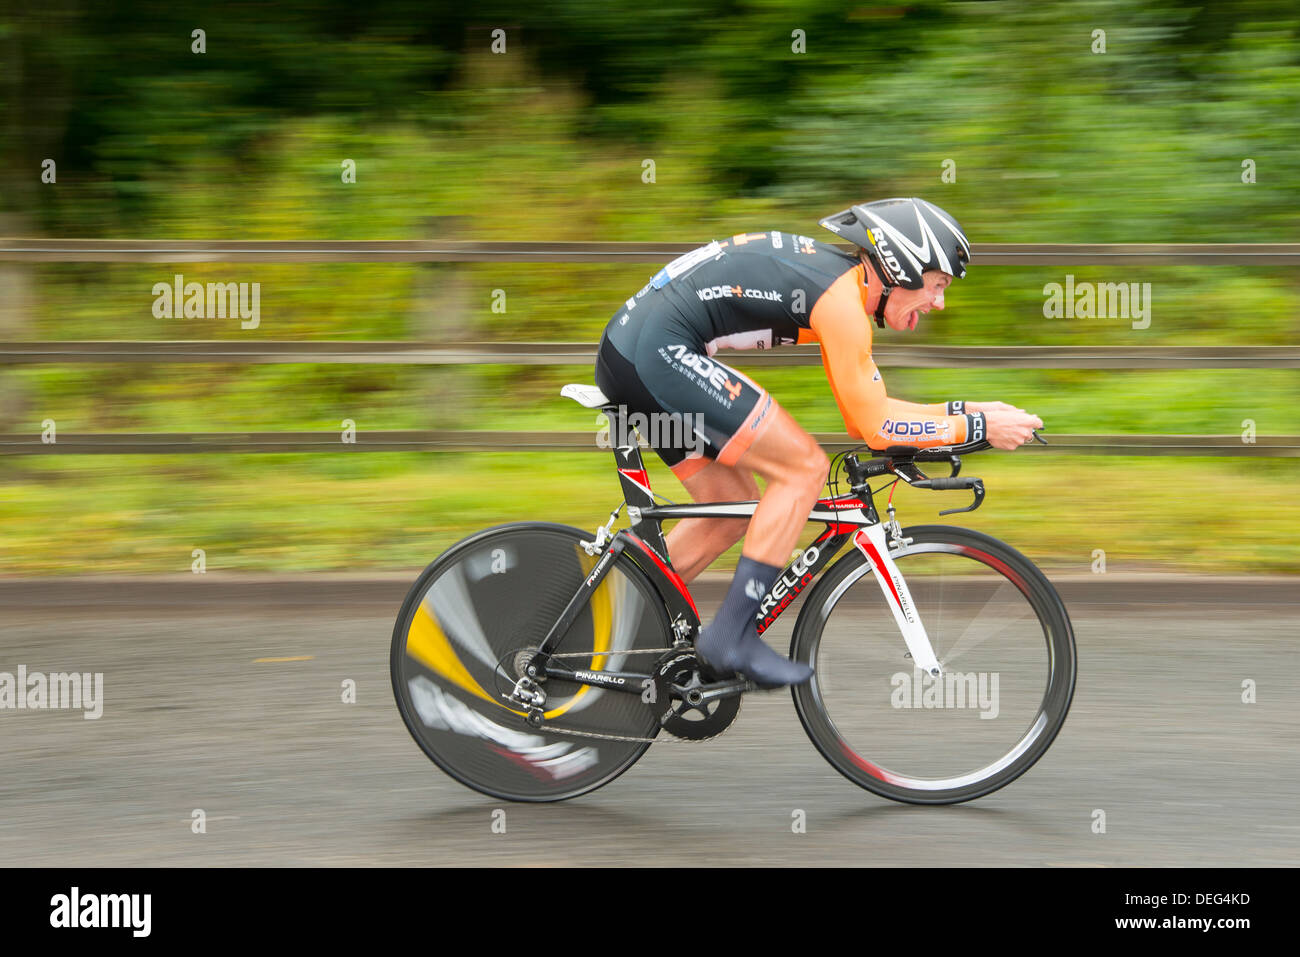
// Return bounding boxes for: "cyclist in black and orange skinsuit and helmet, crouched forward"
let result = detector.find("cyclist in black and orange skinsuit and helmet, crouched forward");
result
[595,199,1043,688]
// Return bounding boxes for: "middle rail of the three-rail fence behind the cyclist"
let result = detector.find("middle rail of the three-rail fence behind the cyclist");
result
[0,341,1300,369]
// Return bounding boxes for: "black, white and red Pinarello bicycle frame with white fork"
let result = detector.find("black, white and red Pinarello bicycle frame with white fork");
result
[527,406,951,694]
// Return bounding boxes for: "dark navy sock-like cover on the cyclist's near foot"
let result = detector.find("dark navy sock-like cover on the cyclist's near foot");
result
[696,555,813,688]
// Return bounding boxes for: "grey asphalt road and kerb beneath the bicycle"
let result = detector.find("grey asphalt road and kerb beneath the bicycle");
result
[0,577,1300,866]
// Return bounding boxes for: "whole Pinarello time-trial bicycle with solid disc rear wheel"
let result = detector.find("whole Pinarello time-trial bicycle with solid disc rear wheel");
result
[391,385,1076,804]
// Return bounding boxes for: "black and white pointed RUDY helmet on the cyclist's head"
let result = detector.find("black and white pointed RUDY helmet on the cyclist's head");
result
[820,199,971,289]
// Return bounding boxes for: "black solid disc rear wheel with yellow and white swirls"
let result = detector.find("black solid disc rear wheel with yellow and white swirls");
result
[390,523,671,801]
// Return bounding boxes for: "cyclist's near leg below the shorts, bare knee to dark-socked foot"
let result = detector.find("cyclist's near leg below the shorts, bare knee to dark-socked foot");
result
[696,402,831,687]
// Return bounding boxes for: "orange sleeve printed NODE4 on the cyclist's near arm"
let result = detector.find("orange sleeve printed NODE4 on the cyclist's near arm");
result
[809,281,983,449]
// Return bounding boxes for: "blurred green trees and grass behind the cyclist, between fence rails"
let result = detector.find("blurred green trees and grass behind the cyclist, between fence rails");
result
[0,0,1300,575]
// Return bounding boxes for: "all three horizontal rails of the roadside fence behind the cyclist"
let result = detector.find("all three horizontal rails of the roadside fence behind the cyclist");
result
[0,238,1300,458]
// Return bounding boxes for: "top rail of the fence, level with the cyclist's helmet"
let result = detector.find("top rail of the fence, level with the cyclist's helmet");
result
[0,238,1300,265]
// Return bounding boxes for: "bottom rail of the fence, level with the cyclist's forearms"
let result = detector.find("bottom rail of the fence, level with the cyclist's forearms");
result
[0,429,1300,458]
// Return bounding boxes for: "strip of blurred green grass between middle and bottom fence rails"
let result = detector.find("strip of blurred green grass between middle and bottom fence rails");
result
[10,355,1300,434]
